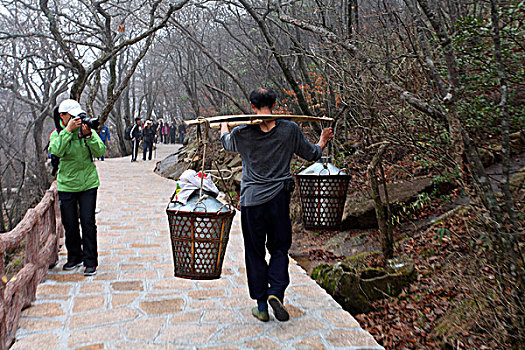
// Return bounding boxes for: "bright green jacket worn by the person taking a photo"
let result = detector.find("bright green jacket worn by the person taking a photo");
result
[49,124,106,192]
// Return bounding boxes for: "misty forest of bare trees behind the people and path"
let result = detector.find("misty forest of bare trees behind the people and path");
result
[0,0,525,348]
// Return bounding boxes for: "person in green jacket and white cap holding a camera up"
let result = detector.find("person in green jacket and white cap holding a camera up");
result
[49,100,106,276]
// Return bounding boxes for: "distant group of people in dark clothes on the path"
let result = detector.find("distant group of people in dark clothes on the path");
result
[128,118,186,162]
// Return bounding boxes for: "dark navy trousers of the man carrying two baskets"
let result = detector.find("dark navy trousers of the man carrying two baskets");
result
[241,190,292,301]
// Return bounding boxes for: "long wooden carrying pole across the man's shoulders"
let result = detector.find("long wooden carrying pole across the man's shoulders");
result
[184,114,334,129]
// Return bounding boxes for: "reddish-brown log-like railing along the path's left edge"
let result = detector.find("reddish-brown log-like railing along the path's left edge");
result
[0,182,64,350]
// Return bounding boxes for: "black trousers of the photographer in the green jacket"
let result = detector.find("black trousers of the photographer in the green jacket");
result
[58,188,98,267]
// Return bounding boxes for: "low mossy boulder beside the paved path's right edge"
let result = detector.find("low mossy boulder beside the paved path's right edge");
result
[312,258,416,315]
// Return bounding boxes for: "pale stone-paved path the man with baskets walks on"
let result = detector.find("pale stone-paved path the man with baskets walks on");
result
[11,145,381,350]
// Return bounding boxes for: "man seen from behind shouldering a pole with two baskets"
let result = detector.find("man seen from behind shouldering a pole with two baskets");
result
[221,88,334,322]
